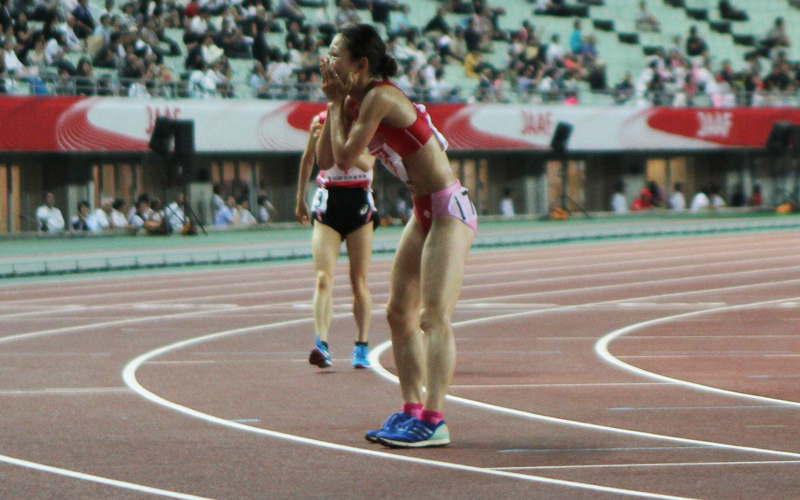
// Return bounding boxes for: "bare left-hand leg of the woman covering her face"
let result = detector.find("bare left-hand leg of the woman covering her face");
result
[386,217,425,403]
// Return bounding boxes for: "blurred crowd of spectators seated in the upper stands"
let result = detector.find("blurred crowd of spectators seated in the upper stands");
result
[0,0,800,102]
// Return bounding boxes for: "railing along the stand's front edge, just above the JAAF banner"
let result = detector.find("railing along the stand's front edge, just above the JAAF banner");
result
[0,74,800,108]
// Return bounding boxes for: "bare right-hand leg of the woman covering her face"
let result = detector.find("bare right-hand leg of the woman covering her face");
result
[420,217,475,412]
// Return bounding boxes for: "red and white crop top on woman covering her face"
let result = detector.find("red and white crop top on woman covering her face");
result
[354,81,447,183]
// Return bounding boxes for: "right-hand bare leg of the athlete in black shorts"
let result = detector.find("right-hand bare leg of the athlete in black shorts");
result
[345,222,375,342]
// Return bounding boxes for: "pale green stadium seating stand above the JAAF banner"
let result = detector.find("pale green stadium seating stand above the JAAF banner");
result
[0,0,800,105]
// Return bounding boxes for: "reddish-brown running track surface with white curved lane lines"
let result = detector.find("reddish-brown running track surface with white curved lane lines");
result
[0,231,800,500]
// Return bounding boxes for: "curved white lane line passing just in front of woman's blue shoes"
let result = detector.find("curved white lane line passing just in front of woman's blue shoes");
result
[122,314,700,500]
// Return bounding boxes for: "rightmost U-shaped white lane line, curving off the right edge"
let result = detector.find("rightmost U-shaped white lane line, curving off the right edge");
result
[594,297,800,408]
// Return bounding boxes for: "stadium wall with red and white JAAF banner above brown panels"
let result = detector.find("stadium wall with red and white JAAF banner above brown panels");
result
[0,96,800,232]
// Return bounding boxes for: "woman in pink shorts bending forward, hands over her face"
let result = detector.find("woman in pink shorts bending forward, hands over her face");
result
[320,24,477,448]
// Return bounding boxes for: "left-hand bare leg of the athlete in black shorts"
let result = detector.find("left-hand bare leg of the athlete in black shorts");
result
[311,222,342,342]
